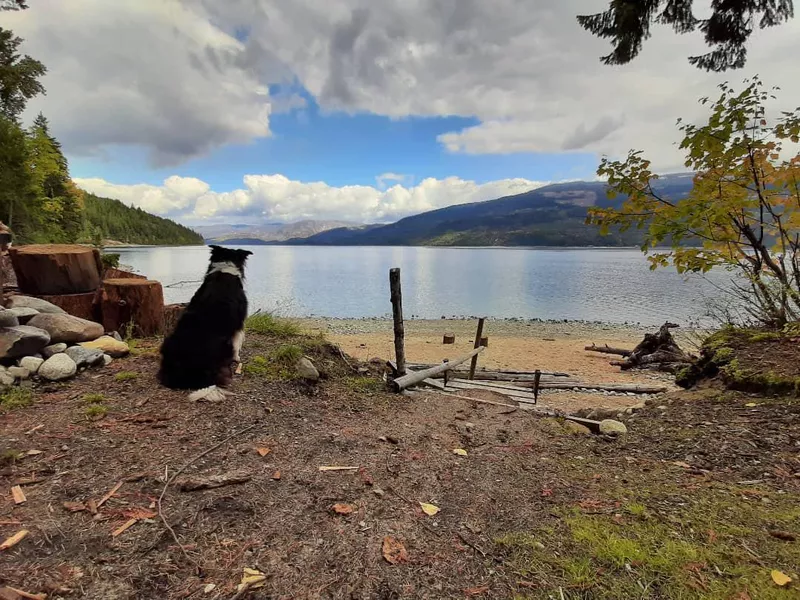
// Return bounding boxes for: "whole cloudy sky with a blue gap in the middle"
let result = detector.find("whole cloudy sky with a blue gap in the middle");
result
[0,0,800,225]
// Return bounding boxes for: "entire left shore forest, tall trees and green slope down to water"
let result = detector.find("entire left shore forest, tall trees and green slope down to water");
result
[0,12,203,244]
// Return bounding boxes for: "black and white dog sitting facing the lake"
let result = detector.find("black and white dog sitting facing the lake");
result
[158,246,252,401]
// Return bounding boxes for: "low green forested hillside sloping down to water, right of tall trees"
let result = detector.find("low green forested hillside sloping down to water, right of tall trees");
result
[83,194,203,246]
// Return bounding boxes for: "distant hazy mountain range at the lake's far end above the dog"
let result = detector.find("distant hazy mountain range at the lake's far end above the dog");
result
[193,220,353,244]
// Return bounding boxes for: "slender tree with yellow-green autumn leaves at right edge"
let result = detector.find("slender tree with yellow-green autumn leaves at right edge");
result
[587,78,800,327]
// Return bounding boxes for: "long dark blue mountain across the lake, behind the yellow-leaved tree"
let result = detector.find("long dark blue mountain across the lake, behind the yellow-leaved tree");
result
[284,173,693,246]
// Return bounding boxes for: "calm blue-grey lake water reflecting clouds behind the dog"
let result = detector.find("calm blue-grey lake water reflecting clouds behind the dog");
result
[114,246,728,325]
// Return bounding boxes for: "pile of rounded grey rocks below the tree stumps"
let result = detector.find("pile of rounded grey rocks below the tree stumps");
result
[0,296,130,385]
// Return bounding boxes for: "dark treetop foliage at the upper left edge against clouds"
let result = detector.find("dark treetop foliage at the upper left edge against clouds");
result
[0,27,47,121]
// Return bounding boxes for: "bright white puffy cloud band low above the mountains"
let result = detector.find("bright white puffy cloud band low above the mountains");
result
[75,175,547,224]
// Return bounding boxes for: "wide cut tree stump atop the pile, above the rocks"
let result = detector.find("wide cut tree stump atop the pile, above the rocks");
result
[9,244,103,296]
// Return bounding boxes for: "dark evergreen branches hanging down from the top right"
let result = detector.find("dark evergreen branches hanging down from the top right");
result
[578,0,794,72]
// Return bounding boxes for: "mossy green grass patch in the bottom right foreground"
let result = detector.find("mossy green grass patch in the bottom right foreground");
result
[495,482,800,600]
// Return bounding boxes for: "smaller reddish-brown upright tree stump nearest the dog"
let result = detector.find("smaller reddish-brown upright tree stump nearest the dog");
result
[100,279,164,337]
